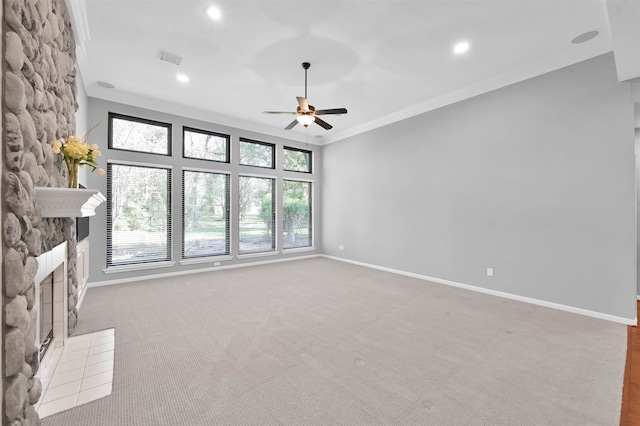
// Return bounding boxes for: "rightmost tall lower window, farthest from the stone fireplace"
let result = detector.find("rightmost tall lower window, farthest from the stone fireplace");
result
[282,180,312,249]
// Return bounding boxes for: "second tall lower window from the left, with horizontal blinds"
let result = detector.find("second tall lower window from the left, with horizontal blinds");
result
[182,170,229,259]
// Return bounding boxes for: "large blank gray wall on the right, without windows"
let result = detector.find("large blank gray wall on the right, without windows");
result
[321,54,636,319]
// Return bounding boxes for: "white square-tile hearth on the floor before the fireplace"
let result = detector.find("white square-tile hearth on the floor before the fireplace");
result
[36,328,115,418]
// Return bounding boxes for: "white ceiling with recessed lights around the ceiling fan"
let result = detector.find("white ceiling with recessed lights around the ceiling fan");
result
[67,0,612,144]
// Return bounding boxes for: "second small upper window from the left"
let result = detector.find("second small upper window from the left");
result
[182,127,231,163]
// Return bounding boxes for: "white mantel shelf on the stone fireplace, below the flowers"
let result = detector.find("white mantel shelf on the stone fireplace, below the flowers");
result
[34,186,106,217]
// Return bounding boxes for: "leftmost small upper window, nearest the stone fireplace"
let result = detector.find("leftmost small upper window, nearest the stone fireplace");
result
[109,113,171,155]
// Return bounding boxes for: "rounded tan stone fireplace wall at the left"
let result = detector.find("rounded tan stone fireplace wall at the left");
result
[2,0,78,426]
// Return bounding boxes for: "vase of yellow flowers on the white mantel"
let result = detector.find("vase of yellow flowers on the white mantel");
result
[52,125,104,188]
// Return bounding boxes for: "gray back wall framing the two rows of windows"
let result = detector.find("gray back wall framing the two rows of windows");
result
[86,97,322,284]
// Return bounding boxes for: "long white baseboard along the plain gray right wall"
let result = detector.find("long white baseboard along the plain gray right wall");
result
[320,254,640,325]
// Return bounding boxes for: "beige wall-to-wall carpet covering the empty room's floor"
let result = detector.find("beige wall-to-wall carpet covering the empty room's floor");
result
[42,258,626,426]
